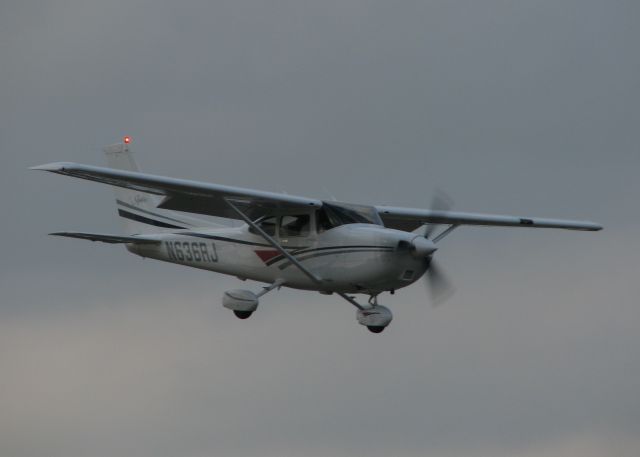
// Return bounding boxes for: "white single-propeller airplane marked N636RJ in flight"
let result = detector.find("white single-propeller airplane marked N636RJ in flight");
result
[32,136,602,333]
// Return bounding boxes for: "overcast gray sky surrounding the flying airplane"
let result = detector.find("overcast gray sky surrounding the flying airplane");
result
[0,0,640,457]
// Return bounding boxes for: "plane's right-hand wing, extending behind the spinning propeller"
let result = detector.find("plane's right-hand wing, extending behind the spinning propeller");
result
[375,206,602,231]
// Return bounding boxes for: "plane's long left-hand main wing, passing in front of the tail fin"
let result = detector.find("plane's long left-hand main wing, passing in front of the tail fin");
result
[32,162,322,219]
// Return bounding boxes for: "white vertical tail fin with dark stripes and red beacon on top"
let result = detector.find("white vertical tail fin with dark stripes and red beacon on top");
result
[104,137,205,235]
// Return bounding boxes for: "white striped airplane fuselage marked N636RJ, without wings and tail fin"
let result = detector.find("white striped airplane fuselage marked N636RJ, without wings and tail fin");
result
[127,224,428,294]
